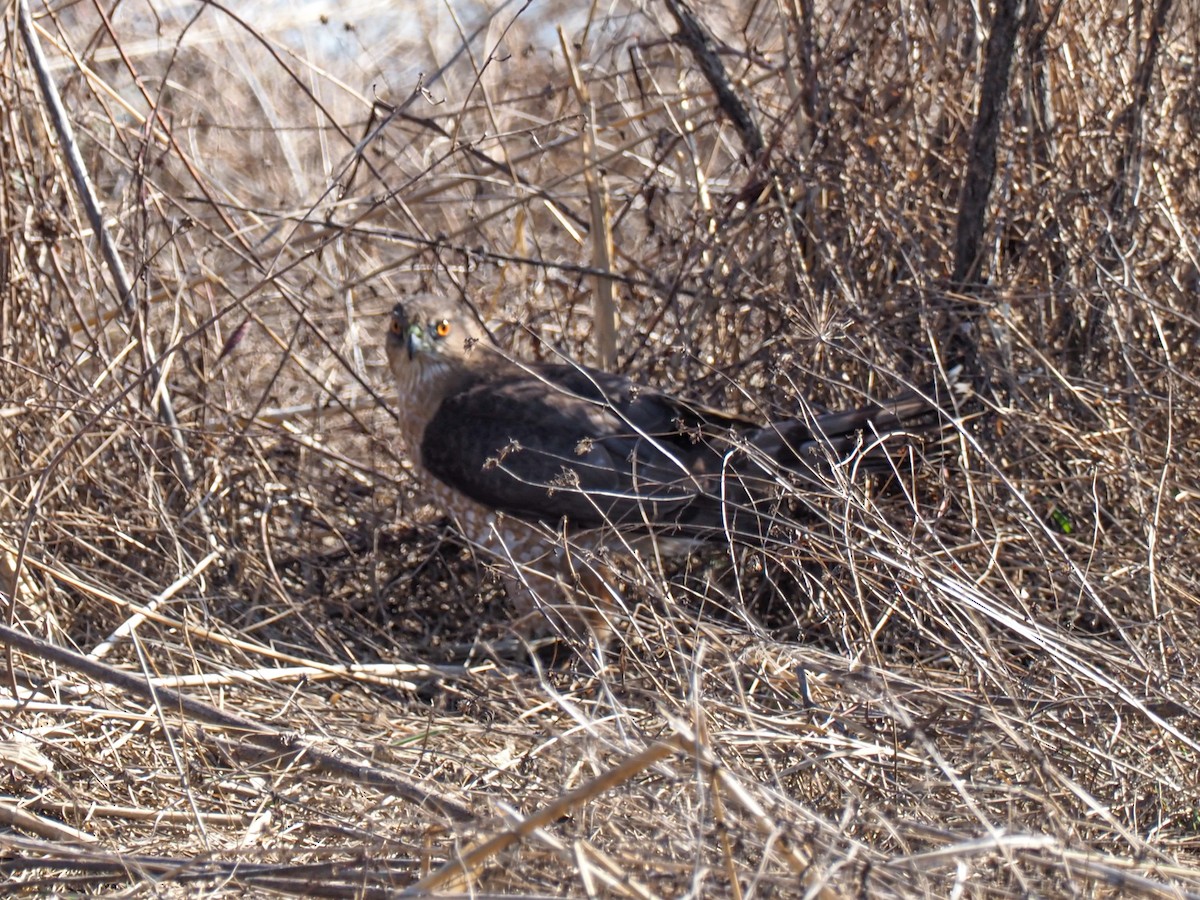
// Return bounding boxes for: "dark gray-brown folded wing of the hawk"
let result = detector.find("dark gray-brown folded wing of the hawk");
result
[421,366,738,527]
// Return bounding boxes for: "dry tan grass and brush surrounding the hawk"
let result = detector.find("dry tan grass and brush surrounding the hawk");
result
[0,0,1200,896]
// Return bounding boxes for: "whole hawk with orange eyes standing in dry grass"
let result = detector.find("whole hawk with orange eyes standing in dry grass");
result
[388,296,942,632]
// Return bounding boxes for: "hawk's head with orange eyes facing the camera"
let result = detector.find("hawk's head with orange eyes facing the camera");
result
[388,296,480,391]
